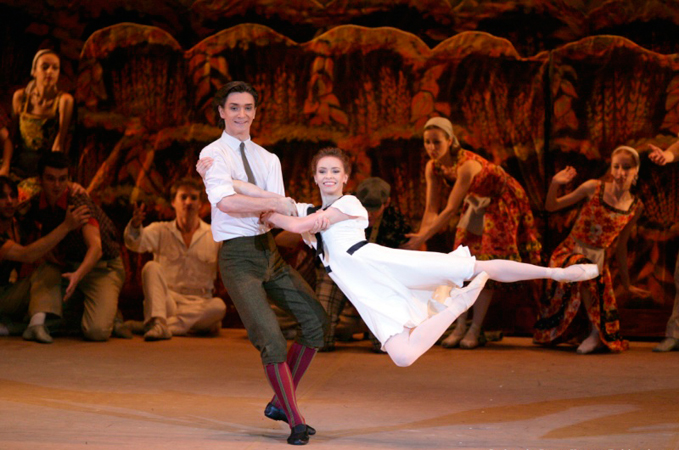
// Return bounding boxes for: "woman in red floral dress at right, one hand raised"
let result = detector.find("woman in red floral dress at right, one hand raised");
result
[534,146,647,354]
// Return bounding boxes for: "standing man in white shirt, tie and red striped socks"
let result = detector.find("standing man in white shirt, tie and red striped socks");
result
[200,81,327,445]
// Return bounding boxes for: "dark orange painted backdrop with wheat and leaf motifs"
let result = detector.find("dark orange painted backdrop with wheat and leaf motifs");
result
[0,0,679,336]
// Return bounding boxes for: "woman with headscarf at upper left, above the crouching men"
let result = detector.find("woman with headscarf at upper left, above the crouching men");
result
[10,49,73,178]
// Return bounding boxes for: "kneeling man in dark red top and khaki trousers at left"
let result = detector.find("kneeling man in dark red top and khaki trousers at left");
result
[24,152,125,341]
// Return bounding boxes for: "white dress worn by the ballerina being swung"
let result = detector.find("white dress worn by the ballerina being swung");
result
[297,195,485,345]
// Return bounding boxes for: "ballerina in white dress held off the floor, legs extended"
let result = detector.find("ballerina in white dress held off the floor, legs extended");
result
[203,148,598,367]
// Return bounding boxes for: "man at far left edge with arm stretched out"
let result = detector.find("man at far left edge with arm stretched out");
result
[0,175,90,344]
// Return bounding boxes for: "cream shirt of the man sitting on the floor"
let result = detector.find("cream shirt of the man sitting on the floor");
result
[124,220,220,298]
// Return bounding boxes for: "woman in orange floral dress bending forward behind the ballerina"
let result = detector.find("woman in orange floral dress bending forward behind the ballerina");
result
[404,117,540,349]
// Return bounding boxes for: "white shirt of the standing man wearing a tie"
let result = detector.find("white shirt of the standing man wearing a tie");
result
[200,132,285,241]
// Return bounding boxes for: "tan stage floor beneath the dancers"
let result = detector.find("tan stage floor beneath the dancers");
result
[0,329,679,450]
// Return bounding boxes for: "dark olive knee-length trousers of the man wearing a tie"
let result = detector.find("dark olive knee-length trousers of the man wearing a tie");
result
[219,233,327,364]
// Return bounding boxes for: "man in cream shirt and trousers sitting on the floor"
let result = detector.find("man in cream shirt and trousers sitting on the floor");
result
[125,178,226,341]
